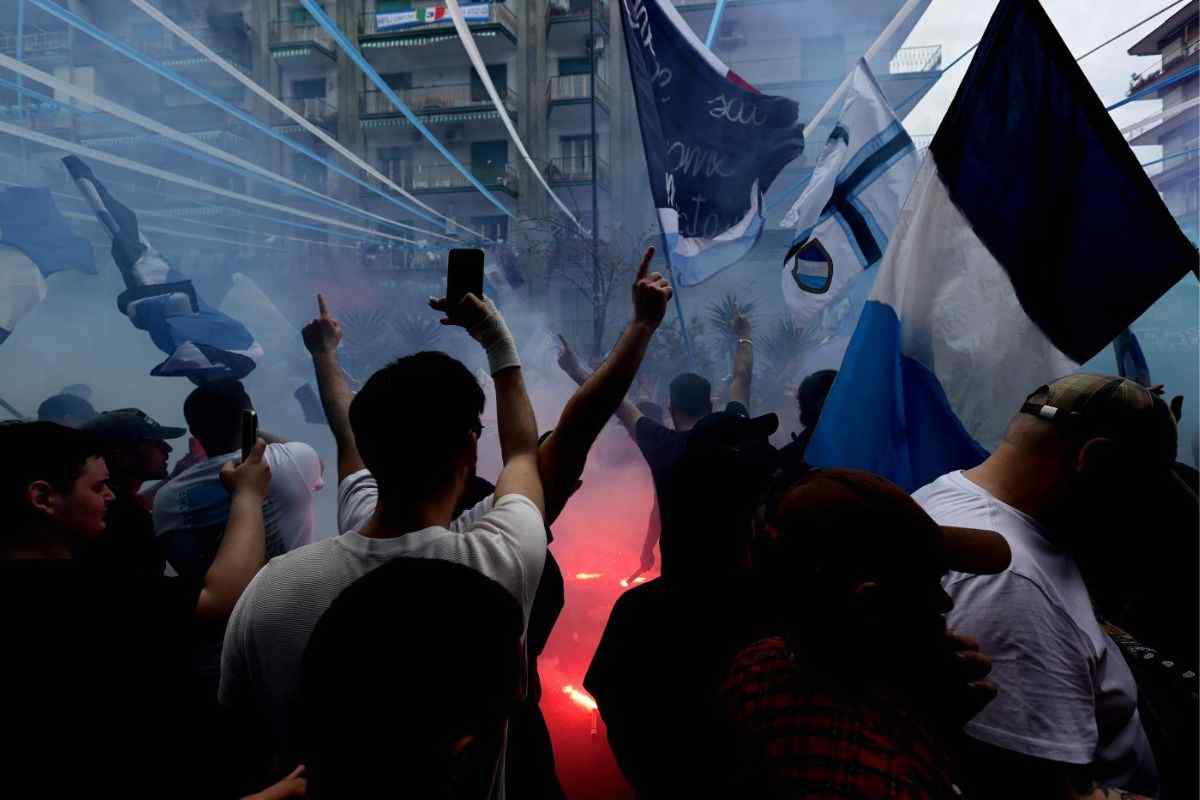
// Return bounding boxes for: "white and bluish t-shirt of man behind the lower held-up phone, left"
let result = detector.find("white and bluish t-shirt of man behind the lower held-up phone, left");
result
[154,441,325,575]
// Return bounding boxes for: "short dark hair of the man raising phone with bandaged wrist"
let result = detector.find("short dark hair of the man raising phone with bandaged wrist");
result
[349,350,484,498]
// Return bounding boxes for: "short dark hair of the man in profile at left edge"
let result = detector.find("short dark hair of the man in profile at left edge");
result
[0,421,103,529]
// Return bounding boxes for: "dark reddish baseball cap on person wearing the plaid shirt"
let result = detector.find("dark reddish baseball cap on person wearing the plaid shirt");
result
[772,469,1013,583]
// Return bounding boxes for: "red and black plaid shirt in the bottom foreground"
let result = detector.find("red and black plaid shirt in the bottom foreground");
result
[721,638,961,800]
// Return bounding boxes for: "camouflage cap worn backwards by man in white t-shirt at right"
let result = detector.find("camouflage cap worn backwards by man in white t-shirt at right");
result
[1021,373,1178,469]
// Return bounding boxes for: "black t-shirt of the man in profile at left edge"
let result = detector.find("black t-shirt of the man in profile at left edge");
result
[0,560,211,798]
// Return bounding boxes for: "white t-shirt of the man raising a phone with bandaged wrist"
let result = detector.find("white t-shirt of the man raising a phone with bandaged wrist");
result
[220,470,546,798]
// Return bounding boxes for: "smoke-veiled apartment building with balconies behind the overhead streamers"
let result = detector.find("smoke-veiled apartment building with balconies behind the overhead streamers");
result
[0,0,941,337]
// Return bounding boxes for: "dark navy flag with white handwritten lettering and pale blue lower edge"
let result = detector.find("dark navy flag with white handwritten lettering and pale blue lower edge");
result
[620,0,804,287]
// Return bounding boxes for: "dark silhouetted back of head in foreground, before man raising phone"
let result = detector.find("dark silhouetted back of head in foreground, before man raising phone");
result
[294,558,524,798]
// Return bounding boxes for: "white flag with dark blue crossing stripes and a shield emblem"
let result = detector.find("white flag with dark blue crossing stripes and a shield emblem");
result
[782,59,920,329]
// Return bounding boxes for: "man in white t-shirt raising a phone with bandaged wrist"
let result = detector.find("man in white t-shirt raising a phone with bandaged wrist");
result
[220,294,546,798]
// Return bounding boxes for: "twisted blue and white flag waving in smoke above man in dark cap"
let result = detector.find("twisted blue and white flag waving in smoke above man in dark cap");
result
[62,156,263,383]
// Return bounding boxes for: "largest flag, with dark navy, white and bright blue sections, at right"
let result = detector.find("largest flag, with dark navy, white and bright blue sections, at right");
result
[808,0,1196,489]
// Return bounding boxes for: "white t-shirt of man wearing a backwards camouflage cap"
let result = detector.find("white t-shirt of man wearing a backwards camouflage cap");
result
[913,471,1158,796]
